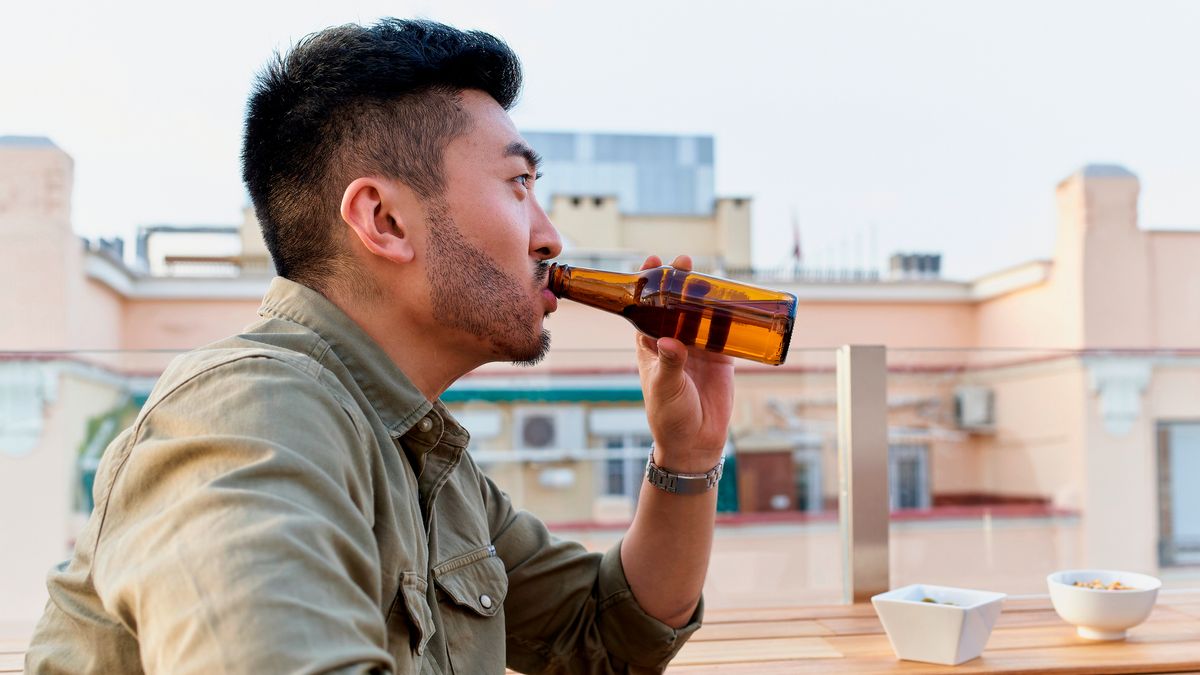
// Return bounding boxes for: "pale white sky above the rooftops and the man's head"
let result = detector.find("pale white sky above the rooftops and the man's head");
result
[0,0,1200,279]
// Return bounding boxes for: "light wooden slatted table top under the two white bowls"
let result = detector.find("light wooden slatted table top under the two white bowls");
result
[667,591,1200,675]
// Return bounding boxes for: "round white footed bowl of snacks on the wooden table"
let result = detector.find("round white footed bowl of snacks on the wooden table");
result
[1046,569,1163,640]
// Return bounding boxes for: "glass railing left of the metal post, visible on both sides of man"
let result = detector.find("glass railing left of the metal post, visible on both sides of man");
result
[0,348,841,621]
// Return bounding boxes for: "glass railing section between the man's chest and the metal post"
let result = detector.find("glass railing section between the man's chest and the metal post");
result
[444,348,841,608]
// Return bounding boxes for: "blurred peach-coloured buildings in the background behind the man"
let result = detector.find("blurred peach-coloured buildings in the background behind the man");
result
[0,132,1200,620]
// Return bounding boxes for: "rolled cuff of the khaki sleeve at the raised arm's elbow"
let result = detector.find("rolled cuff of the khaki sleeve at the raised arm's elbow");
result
[599,542,704,671]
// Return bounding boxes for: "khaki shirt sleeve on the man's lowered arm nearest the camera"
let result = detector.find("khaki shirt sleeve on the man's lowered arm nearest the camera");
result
[92,357,403,674]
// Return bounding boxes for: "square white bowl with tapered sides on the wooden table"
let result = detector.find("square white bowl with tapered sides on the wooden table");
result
[871,584,1004,665]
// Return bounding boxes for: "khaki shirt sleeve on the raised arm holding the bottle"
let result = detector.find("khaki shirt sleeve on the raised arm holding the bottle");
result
[480,461,703,674]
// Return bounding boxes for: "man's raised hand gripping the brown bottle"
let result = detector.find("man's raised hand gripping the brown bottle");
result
[637,251,733,473]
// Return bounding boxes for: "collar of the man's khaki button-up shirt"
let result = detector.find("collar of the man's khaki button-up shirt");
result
[258,276,444,438]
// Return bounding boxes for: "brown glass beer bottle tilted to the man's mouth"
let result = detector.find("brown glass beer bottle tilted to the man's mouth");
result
[548,263,796,365]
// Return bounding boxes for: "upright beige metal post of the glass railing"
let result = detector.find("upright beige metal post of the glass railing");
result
[838,345,889,603]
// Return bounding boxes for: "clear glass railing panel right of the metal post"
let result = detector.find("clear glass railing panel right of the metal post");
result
[888,350,1200,593]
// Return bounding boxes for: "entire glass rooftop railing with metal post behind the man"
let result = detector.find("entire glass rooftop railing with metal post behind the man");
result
[0,346,1200,621]
